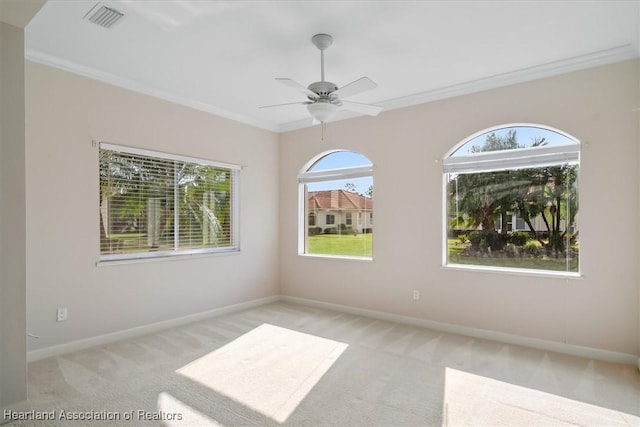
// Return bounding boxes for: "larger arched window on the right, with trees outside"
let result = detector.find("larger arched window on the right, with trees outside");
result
[443,125,580,275]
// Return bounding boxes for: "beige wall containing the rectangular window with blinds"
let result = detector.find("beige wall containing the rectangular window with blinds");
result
[25,62,279,350]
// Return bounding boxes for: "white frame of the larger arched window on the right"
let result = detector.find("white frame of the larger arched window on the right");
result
[441,123,582,278]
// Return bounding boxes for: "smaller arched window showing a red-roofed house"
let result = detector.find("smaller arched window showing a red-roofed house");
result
[298,151,373,259]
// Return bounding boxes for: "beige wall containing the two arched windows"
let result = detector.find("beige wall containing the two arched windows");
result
[280,61,640,354]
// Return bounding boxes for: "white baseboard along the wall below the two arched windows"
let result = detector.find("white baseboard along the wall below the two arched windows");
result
[281,295,640,369]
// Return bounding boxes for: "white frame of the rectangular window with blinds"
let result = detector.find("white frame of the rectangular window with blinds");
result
[97,142,242,265]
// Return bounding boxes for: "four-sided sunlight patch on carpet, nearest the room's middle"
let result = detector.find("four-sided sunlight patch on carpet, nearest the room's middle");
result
[176,323,347,423]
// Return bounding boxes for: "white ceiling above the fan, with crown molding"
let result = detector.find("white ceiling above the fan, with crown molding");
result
[25,0,640,131]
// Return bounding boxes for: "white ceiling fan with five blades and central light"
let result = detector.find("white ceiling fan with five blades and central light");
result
[260,34,382,123]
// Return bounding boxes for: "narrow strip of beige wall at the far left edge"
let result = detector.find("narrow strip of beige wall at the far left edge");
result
[0,20,27,414]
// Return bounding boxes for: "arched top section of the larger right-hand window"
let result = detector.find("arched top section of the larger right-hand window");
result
[443,124,580,172]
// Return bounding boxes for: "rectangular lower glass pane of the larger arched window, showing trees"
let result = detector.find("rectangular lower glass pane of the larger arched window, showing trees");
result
[447,164,579,272]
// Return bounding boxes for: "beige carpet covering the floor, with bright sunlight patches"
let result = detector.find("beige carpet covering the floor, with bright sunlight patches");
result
[9,303,640,427]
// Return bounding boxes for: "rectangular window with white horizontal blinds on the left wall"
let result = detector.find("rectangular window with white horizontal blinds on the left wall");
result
[99,143,240,261]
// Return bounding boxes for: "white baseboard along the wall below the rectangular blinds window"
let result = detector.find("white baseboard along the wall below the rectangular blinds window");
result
[27,295,280,362]
